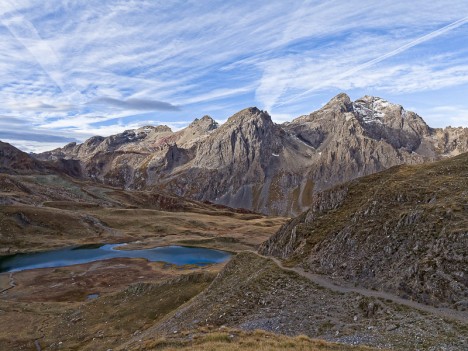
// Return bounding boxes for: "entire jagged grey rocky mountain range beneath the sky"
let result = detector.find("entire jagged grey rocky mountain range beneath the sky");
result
[38,94,468,215]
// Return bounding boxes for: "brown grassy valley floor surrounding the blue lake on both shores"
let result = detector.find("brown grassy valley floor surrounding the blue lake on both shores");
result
[0,151,286,350]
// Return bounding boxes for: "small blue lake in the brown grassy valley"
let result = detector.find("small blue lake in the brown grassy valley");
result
[0,244,231,273]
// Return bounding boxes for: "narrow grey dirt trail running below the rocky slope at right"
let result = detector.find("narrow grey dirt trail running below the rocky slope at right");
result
[250,251,468,324]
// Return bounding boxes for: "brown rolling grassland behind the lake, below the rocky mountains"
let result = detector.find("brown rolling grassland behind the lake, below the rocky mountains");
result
[0,140,285,255]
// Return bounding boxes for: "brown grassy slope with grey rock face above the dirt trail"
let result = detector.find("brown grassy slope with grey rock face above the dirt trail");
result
[260,153,468,311]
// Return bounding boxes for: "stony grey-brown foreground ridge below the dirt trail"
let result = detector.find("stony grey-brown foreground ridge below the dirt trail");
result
[139,253,468,351]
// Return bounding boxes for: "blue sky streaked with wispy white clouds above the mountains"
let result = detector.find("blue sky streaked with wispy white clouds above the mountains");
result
[0,0,468,152]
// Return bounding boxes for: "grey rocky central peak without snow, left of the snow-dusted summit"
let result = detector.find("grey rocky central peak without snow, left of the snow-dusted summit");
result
[159,108,305,213]
